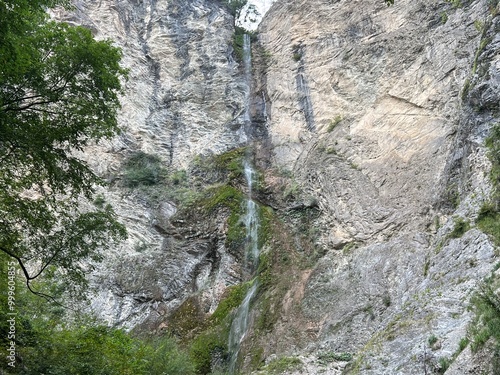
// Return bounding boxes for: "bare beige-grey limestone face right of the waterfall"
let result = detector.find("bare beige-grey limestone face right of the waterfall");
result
[254,0,498,374]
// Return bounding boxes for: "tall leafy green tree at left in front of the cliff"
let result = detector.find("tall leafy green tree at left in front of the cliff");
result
[0,0,126,300]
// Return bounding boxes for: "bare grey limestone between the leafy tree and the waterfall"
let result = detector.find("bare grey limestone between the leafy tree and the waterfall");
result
[54,0,249,328]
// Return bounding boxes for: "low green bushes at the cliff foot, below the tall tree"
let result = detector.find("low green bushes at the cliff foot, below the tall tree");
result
[0,255,194,375]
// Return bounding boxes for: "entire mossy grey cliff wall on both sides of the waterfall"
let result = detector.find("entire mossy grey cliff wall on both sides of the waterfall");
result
[57,0,500,374]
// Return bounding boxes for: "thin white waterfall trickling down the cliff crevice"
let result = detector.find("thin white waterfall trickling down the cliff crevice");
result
[228,34,259,374]
